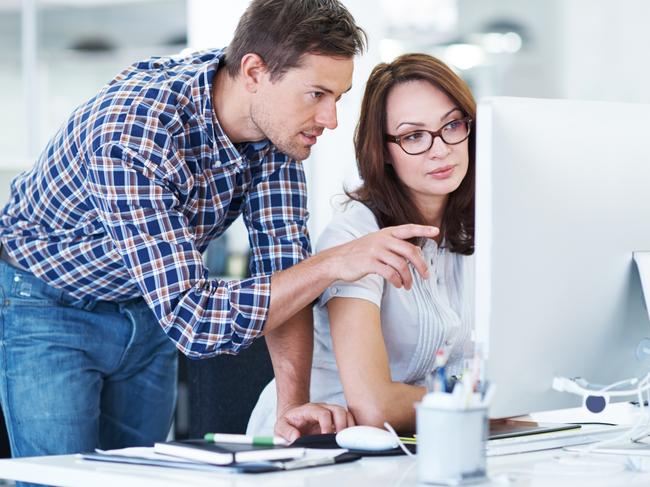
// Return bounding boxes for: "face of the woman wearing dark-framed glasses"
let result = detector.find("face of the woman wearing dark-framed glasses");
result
[386,80,469,209]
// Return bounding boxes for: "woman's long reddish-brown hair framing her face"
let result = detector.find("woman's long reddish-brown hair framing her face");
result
[346,54,476,255]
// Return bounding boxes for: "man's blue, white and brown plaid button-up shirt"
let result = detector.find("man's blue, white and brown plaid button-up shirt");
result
[0,50,310,358]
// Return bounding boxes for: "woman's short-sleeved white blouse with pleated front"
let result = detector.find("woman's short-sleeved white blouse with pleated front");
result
[247,201,474,435]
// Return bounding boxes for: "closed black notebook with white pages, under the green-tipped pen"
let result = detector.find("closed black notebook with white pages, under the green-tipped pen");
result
[153,440,305,465]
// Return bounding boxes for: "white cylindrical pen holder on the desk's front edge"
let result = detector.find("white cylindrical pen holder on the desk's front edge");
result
[415,402,488,485]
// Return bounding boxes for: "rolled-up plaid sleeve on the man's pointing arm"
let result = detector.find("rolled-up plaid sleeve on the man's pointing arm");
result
[88,145,268,358]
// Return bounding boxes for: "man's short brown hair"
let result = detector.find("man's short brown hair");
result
[225,0,366,81]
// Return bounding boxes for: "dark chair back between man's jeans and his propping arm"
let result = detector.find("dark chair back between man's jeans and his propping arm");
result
[182,338,273,438]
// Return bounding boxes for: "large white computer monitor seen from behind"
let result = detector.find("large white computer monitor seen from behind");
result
[475,97,650,418]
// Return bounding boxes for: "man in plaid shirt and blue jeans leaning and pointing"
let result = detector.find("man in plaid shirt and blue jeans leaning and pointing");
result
[0,0,437,456]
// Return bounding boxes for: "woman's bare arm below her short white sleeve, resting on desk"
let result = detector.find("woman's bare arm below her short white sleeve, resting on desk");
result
[327,298,426,432]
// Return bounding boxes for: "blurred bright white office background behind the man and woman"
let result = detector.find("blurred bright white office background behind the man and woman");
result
[0,0,650,458]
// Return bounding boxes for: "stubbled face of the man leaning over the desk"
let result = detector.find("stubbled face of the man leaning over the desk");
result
[250,54,354,161]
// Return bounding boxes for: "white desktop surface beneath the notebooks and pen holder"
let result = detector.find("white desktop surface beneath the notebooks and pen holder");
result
[0,404,650,487]
